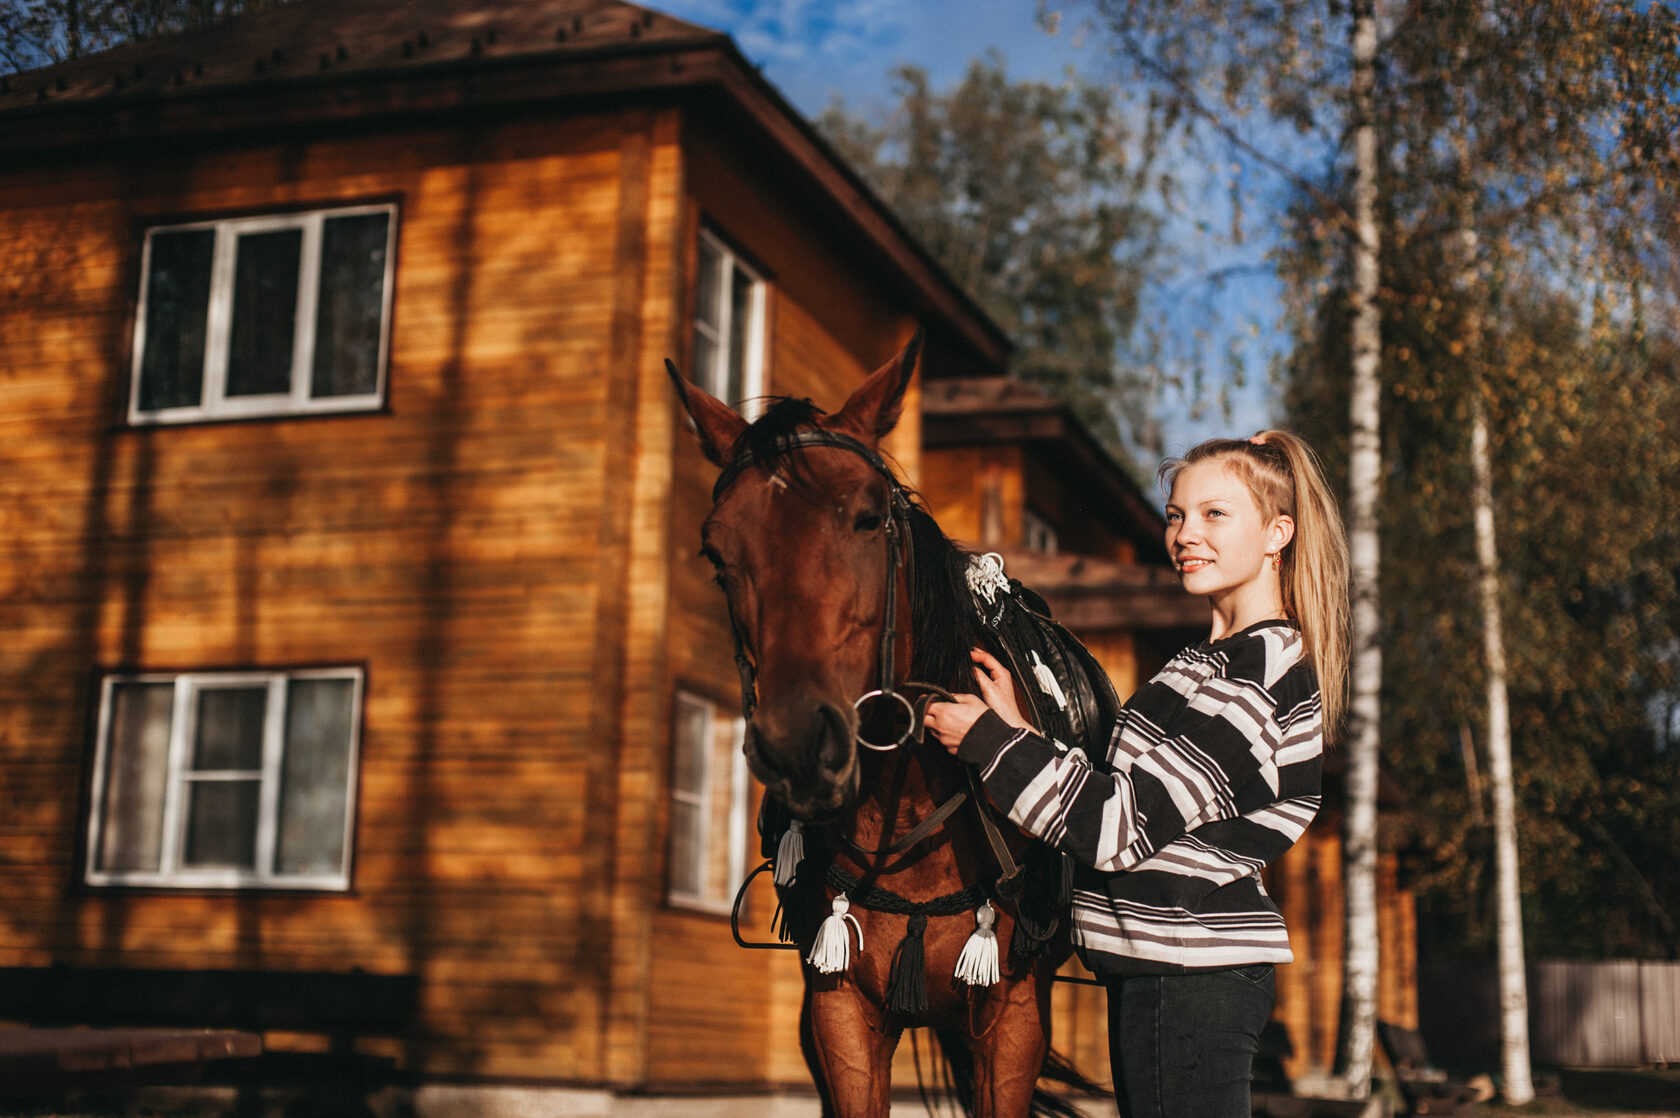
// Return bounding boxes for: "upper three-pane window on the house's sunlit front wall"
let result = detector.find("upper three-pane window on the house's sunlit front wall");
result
[128,205,396,424]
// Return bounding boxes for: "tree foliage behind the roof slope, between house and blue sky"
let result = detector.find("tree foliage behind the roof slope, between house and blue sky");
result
[818,55,1159,452]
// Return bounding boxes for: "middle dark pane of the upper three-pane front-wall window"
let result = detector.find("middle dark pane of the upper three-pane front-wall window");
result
[227,229,304,397]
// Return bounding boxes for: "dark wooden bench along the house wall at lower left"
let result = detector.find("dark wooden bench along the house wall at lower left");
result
[0,965,420,1094]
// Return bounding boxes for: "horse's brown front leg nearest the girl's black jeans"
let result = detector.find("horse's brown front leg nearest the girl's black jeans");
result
[968,960,1055,1118]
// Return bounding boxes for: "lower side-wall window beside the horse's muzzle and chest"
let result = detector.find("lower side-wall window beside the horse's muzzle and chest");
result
[670,691,748,911]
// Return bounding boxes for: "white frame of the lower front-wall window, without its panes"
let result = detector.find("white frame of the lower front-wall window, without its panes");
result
[84,667,363,891]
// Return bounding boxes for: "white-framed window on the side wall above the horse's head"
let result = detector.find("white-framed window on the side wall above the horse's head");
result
[694,229,764,412]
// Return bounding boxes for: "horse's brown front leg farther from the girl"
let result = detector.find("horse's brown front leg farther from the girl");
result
[805,968,900,1118]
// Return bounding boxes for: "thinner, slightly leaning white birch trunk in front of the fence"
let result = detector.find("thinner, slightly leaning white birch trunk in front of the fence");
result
[1470,388,1534,1106]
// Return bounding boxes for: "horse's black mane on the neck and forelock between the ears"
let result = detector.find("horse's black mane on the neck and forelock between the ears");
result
[731,397,983,693]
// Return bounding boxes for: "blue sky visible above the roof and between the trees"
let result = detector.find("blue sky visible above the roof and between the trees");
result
[650,0,1278,454]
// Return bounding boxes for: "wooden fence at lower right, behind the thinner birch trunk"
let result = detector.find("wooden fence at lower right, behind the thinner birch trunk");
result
[1418,960,1680,1071]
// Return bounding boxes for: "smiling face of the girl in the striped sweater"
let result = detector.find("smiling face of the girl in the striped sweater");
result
[1166,459,1294,597]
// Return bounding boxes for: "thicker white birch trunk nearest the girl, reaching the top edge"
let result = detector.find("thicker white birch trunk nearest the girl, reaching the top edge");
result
[1339,0,1383,1098]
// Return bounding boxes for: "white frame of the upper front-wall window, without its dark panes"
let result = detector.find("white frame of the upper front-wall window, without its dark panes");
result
[128,203,396,425]
